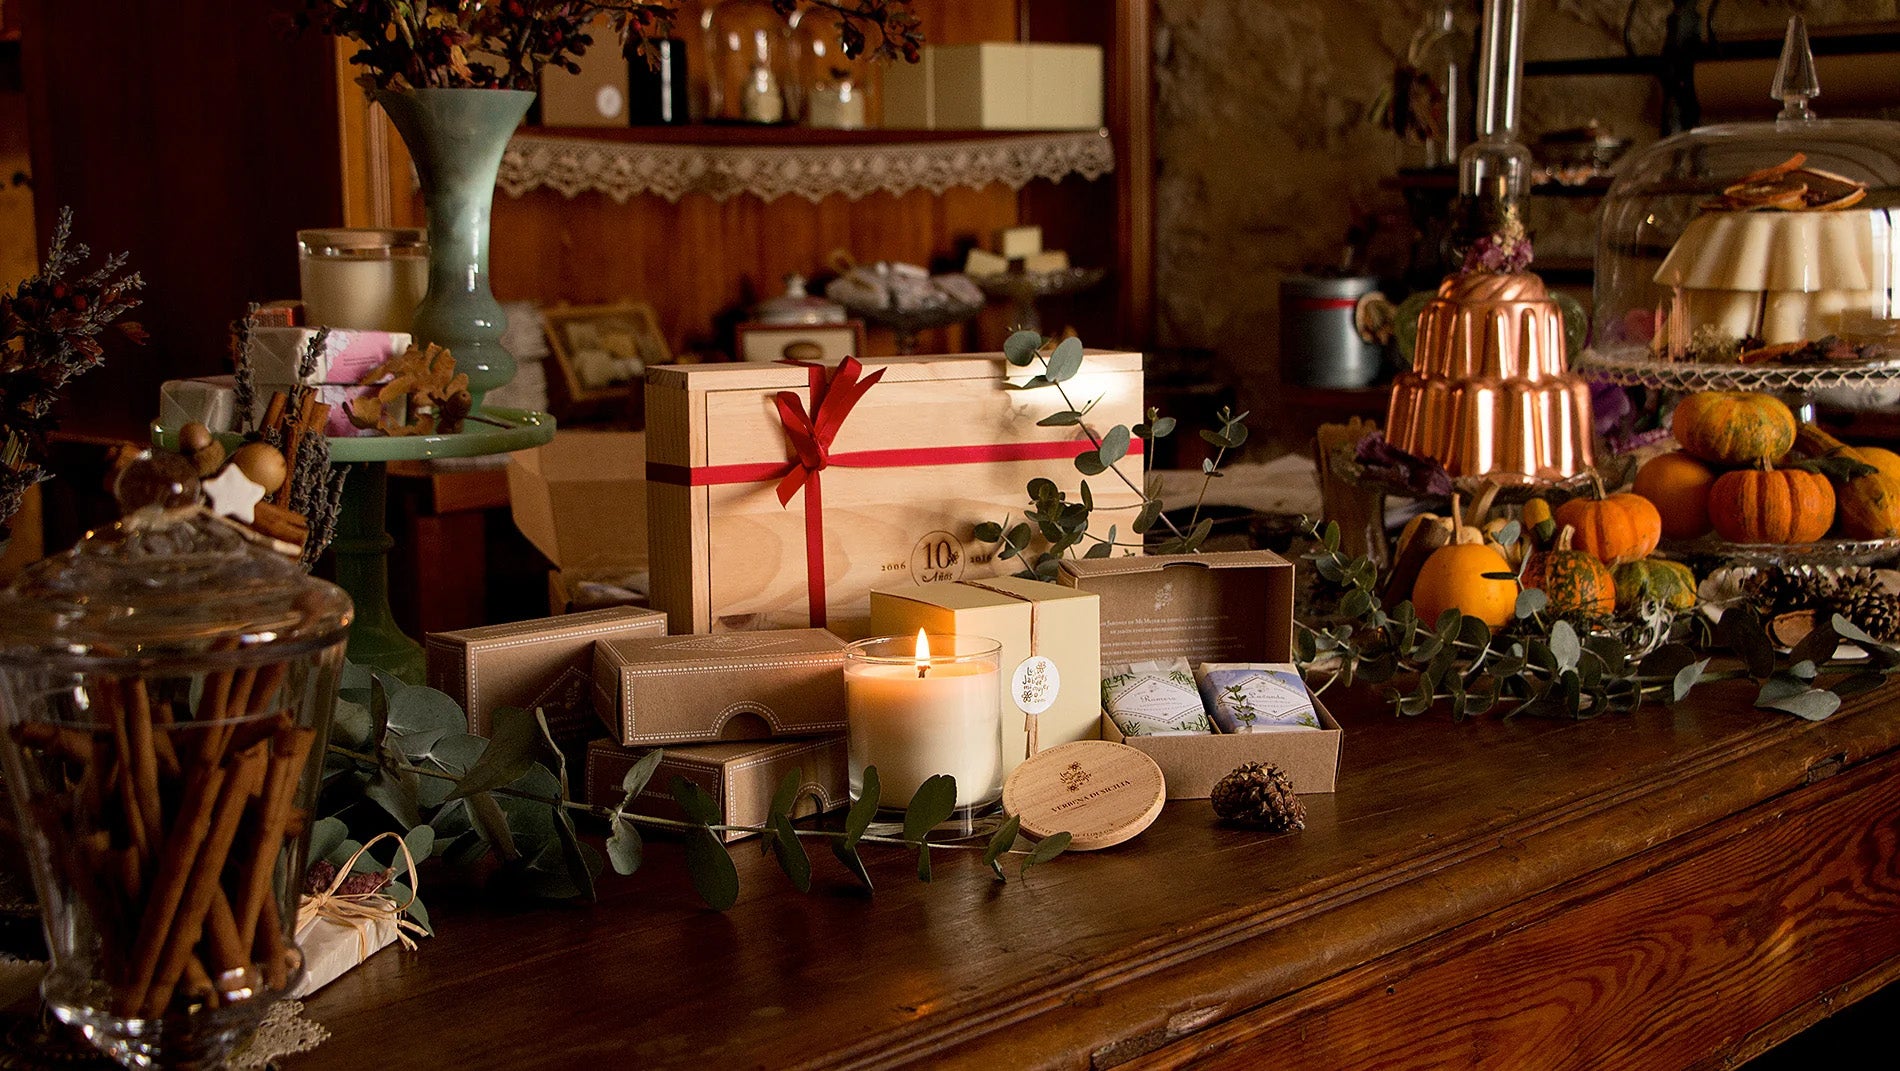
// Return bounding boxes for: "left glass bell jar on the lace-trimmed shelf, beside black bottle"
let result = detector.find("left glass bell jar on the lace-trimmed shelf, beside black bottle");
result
[699,0,798,125]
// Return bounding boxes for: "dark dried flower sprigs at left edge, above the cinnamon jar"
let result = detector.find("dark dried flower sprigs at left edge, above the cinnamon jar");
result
[0,209,144,539]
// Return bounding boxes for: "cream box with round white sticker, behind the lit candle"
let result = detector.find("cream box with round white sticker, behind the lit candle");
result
[870,577,1102,777]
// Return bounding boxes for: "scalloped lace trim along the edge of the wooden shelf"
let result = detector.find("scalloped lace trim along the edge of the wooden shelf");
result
[496,131,1115,203]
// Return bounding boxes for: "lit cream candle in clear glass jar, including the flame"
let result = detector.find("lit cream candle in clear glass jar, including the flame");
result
[844,632,1003,834]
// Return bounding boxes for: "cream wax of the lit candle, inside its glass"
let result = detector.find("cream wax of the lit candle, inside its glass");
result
[844,663,1003,809]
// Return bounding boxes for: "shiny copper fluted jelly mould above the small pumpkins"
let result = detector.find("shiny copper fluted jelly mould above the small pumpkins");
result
[1385,272,1594,482]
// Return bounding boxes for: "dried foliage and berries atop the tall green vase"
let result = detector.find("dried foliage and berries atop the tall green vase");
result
[293,0,923,89]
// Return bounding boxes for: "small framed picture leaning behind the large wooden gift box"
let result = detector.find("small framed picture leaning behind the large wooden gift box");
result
[542,302,673,416]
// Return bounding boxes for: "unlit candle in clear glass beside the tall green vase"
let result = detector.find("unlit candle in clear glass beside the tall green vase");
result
[296,228,429,332]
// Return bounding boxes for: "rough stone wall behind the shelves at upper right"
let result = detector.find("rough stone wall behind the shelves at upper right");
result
[1155,0,1896,440]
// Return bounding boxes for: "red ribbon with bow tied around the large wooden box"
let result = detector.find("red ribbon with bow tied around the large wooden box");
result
[646,357,1142,629]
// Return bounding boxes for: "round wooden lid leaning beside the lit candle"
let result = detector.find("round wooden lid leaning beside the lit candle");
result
[1003,741,1169,851]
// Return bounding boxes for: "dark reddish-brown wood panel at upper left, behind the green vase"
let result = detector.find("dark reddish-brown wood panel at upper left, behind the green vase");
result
[18,0,342,437]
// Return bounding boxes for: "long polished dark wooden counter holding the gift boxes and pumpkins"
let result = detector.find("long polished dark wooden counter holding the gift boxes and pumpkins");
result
[291,684,1900,1071]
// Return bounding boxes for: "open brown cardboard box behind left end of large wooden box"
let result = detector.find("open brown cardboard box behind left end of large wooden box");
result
[507,429,646,613]
